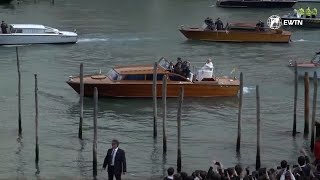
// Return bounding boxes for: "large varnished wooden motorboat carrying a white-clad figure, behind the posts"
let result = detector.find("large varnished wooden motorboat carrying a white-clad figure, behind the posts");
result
[67,58,240,98]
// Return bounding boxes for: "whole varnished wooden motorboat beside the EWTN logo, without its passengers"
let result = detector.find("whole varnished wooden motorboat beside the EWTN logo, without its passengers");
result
[180,23,291,43]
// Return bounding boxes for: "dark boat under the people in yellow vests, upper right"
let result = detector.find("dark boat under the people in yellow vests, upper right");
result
[281,14,320,28]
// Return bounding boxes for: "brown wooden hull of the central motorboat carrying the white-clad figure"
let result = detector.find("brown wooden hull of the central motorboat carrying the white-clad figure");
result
[67,81,239,98]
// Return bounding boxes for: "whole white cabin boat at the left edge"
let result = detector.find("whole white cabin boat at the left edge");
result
[0,24,78,45]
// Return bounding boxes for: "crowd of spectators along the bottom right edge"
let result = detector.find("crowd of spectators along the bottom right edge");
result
[164,148,320,180]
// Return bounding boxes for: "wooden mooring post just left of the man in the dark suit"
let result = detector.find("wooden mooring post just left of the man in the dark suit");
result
[93,87,98,178]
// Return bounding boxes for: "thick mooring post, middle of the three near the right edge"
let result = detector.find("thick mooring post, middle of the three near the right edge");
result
[304,72,310,136]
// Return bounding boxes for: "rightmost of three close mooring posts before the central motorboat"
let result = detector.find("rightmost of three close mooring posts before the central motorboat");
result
[177,87,184,173]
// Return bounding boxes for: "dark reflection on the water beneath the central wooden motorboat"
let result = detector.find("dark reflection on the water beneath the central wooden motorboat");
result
[66,96,239,117]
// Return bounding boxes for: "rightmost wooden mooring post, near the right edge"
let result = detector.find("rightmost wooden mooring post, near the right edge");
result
[310,72,318,151]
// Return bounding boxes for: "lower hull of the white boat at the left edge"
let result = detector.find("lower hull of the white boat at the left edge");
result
[0,34,78,45]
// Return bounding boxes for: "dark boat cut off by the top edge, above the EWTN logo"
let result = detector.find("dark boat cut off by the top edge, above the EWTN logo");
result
[216,0,297,8]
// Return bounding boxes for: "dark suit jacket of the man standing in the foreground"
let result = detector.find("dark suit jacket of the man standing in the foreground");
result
[103,148,127,174]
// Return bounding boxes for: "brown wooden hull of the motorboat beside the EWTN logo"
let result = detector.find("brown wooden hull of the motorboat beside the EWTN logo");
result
[180,29,291,43]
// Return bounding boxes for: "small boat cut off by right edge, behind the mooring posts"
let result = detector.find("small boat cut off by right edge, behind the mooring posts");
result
[288,52,320,79]
